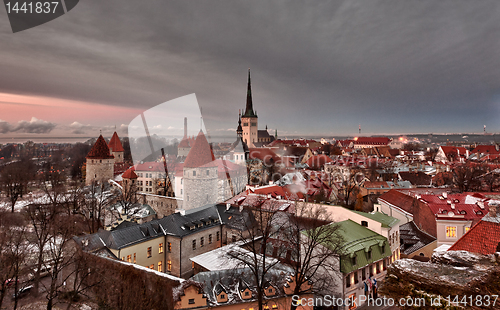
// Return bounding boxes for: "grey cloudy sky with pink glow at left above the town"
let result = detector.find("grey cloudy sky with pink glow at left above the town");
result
[0,0,500,136]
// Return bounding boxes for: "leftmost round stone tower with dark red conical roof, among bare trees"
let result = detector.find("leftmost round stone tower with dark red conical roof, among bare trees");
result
[85,135,115,185]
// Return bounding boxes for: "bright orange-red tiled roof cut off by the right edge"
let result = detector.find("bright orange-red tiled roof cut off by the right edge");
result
[448,218,500,255]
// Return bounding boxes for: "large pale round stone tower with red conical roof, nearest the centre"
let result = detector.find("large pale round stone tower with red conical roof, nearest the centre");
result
[182,130,218,210]
